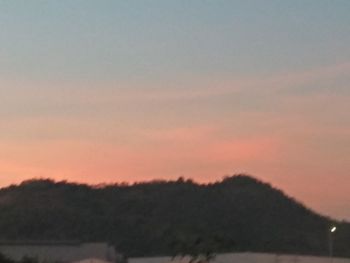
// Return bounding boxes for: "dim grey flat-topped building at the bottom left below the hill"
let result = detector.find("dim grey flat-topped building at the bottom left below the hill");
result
[0,241,122,263]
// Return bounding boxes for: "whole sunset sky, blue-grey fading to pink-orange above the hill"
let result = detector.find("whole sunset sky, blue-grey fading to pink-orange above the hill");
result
[0,0,350,221]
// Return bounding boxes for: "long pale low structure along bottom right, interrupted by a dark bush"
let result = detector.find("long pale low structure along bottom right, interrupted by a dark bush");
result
[128,253,350,263]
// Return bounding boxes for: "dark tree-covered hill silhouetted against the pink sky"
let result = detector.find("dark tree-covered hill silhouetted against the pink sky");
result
[0,175,350,257]
